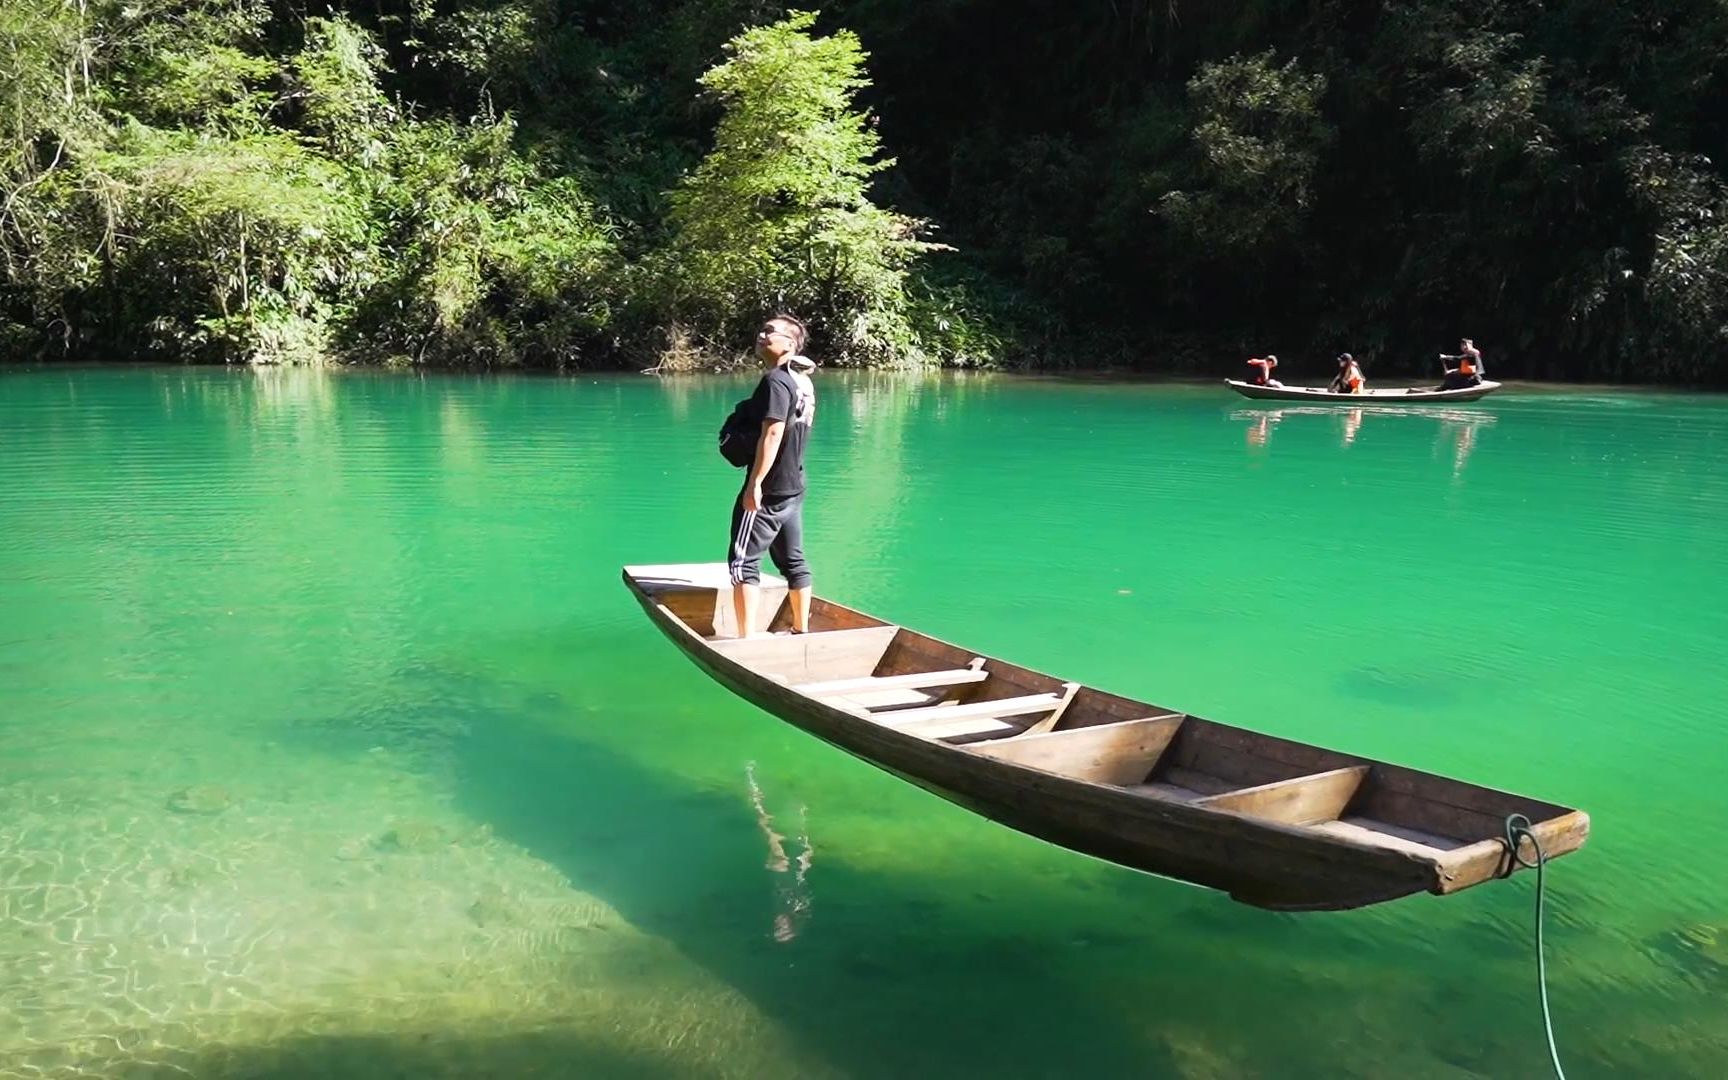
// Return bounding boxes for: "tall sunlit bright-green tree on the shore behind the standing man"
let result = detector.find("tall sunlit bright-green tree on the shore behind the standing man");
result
[657,14,931,361]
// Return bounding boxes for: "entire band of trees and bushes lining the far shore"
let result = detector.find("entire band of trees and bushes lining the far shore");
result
[0,0,1728,385]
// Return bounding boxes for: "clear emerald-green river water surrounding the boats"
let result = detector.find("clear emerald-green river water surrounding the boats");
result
[0,370,1728,1078]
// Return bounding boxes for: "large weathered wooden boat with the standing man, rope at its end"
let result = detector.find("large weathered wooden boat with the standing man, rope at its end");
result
[624,563,1590,911]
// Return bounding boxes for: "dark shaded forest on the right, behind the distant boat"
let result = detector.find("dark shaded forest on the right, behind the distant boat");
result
[846,0,1728,380]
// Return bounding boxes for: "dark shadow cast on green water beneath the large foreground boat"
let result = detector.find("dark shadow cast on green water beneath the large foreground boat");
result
[354,660,1589,1077]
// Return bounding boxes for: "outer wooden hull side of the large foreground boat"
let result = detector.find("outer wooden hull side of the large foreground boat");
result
[626,569,1588,911]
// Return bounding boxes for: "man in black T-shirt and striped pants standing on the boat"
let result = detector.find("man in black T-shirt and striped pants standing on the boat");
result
[726,314,816,638]
